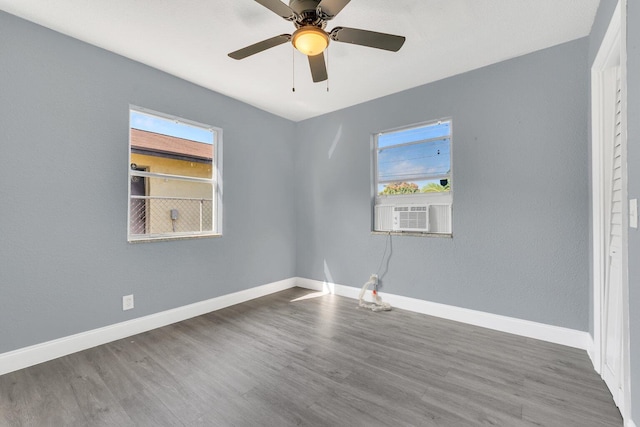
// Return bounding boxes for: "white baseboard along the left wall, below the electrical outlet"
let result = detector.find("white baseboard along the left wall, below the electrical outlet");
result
[0,278,296,375]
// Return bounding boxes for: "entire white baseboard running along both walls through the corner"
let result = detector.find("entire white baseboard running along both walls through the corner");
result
[0,277,596,376]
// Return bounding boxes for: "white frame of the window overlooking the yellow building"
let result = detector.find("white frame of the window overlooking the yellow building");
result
[127,105,223,243]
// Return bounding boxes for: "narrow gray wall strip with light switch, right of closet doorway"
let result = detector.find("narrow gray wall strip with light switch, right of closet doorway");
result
[627,0,640,425]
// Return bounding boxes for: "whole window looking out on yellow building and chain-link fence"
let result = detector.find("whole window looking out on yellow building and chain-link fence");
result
[128,107,222,241]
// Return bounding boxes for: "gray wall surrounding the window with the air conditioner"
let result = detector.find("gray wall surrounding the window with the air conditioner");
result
[296,38,589,331]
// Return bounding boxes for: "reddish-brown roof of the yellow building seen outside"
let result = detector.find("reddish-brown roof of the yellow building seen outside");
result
[131,129,213,159]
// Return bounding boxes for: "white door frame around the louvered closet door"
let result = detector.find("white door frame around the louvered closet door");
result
[589,0,631,420]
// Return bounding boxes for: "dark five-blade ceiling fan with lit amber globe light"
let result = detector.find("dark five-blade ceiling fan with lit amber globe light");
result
[229,0,405,83]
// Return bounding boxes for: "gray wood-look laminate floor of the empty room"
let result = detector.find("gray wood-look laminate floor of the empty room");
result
[0,288,622,427]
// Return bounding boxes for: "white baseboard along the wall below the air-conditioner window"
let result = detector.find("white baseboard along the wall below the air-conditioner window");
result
[296,277,593,352]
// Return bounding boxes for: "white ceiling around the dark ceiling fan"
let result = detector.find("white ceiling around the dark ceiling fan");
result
[0,0,600,121]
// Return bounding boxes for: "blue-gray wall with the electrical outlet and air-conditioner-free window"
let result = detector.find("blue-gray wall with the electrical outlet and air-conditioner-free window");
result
[0,11,295,353]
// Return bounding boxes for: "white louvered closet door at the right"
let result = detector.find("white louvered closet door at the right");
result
[603,66,623,406]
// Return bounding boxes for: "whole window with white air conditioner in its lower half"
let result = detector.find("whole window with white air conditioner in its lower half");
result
[373,120,453,234]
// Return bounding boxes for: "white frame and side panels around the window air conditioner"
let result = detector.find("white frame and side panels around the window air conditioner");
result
[371,117,453,237]
